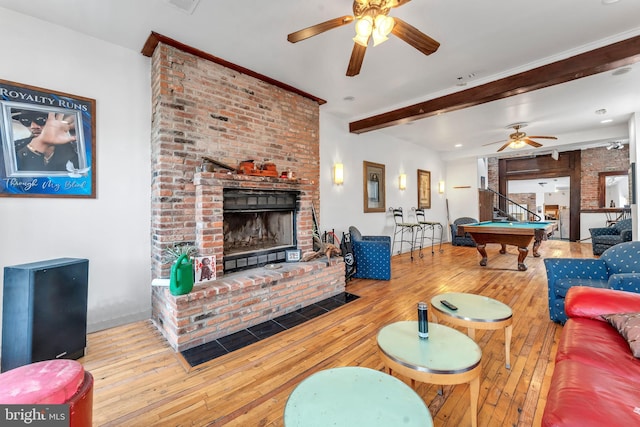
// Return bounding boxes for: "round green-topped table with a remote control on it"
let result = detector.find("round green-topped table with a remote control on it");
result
[430,292,513,369]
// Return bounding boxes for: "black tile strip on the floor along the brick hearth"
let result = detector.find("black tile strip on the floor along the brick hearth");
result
[180,292,359,368]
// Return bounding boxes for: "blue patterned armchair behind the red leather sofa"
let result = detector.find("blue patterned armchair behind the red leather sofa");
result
[544,241,640,324]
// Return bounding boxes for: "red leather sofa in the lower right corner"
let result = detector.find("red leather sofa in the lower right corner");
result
[542,286,640,427]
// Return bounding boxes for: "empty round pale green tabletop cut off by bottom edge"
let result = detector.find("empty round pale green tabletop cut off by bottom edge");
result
[284,366,433,427]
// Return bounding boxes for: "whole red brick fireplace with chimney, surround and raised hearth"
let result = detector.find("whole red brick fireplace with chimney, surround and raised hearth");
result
[145,37,345,351]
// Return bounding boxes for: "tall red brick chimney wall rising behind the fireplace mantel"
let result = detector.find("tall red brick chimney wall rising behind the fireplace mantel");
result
[151,44,320,277]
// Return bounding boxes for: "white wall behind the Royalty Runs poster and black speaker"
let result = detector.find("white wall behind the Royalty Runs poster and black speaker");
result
[0,8,151,342]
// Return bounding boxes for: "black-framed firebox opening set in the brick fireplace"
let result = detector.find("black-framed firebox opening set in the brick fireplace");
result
[223,189,299,273]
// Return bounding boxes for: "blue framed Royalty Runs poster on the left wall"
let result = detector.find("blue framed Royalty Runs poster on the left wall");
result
[0,80,96,198]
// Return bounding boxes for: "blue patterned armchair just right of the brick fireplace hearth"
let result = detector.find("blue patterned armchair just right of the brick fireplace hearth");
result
[349,226,391,280]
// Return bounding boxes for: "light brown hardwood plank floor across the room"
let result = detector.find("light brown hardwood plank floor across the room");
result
[80,240,592,427]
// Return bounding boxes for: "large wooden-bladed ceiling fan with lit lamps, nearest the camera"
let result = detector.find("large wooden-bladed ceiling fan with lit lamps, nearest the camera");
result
[287,0,440,77]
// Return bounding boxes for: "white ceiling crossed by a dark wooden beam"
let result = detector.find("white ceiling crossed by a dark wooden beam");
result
[0,0,640,159]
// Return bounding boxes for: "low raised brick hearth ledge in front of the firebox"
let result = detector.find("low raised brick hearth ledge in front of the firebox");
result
[152,258,345,351]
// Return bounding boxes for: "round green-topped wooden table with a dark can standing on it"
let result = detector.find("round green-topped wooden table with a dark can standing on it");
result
[378,321,482,427]
